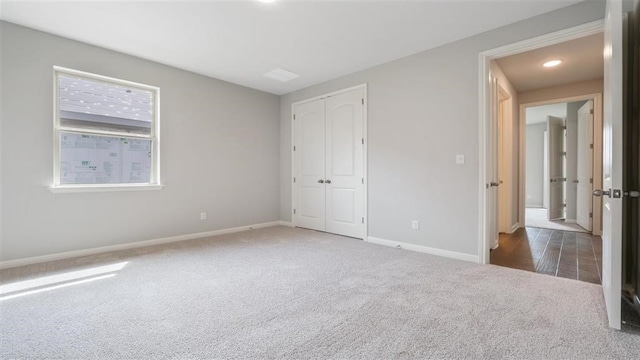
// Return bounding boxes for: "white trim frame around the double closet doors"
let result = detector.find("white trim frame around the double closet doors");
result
[289,83,369,241]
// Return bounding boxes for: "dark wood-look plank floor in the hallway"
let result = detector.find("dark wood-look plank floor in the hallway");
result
[491,227,602,284]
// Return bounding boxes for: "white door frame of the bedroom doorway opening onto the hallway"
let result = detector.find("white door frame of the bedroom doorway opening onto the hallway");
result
[478,20,604,264]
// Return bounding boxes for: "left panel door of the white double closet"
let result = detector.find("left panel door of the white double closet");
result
[293,100,326,231]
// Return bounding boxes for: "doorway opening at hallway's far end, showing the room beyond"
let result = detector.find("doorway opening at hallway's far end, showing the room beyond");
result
[520,97,602,235]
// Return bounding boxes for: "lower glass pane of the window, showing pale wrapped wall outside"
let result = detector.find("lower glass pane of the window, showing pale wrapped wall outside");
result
[60,132,152,184]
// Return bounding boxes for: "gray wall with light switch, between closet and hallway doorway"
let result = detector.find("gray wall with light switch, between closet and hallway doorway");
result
[280,2,604,255]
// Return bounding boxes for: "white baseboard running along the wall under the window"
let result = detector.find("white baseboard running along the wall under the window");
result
[0,221,289,270]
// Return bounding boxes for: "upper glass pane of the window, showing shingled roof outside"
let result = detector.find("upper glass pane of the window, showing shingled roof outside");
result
[58,74,154,135]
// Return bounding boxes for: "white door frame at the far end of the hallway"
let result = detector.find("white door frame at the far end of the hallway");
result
[518,93,602,236]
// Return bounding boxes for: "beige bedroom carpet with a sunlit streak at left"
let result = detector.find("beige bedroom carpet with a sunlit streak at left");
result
[0,227,640,359]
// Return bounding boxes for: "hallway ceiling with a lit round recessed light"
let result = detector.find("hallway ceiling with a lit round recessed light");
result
[496,33,604,92]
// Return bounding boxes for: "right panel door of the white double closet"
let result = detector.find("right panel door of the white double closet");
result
[325,89,364,238]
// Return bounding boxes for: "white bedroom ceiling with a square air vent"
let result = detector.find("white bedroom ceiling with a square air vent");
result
[0,0,581,94]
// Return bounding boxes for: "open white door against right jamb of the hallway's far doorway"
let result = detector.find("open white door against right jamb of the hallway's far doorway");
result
[576,100,593,231]
